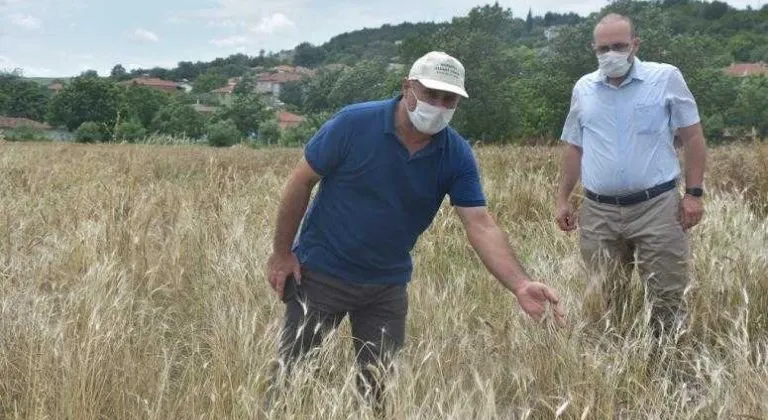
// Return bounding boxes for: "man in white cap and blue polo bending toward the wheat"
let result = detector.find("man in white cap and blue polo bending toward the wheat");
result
[268,52,563,406]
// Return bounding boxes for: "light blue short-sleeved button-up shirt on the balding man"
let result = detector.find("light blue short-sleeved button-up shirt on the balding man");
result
[561,58,699,195]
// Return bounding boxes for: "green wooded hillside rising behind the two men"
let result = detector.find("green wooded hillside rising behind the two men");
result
[10,0,768,142]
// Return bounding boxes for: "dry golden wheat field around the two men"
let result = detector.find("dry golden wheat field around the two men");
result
[0,143,768,420]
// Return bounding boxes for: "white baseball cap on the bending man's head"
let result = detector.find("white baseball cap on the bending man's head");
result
[408,51,469,98]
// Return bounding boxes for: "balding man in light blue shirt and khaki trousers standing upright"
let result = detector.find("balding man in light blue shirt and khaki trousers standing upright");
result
[556,14,707,335]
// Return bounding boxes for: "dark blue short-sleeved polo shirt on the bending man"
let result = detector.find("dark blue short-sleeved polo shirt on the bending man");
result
[293,97,485,284]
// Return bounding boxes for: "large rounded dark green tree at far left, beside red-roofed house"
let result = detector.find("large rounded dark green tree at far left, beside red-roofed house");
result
[48,75,120,131]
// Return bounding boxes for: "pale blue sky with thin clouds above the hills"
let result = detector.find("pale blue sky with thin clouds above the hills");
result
[0,0,768,77]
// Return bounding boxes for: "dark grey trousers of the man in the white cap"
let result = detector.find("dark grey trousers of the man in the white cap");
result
[279,269,408,403]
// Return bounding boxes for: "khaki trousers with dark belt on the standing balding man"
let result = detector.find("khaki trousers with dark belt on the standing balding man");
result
[579,189,690,336]
